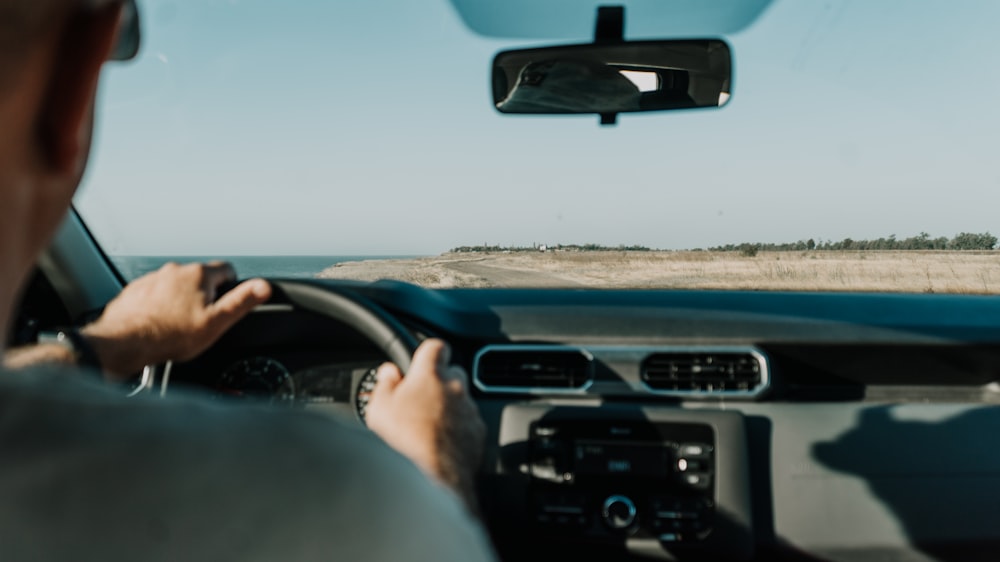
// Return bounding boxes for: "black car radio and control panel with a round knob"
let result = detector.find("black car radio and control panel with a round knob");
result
[529,420,715,543]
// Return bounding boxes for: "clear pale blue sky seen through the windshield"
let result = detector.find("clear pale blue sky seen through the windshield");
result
[76,0,1000,255]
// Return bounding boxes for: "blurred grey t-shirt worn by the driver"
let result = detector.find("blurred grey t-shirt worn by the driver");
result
[0,371,493,562]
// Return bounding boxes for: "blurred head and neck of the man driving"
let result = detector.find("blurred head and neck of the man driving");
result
[0,0,132,342]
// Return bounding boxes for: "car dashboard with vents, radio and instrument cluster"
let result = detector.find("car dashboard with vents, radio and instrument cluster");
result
[170,282,1000,560]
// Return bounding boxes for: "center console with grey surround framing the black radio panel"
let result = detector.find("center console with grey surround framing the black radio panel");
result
[493,404,753,560]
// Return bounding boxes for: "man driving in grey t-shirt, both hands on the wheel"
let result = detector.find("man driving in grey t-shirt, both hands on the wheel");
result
[0,0,492,561]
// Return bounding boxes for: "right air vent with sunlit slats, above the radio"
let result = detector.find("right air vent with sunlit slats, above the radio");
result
[641,349,768,396]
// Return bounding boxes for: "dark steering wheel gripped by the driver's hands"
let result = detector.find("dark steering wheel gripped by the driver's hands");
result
[130,279,420,396]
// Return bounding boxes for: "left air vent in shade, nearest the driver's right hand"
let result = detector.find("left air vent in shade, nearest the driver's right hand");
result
[473,345,593,393]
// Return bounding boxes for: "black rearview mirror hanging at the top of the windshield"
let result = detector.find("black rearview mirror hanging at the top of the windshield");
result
[493,39,732,123]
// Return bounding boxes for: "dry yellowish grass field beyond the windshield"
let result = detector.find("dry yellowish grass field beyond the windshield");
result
[318,251,1000,294]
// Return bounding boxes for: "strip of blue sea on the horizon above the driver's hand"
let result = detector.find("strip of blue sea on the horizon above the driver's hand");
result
[109,256,421,280]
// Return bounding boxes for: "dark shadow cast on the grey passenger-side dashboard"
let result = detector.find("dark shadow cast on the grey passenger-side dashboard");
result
[812,406,1000,562]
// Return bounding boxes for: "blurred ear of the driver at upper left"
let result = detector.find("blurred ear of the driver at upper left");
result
[38,2,122,174]
